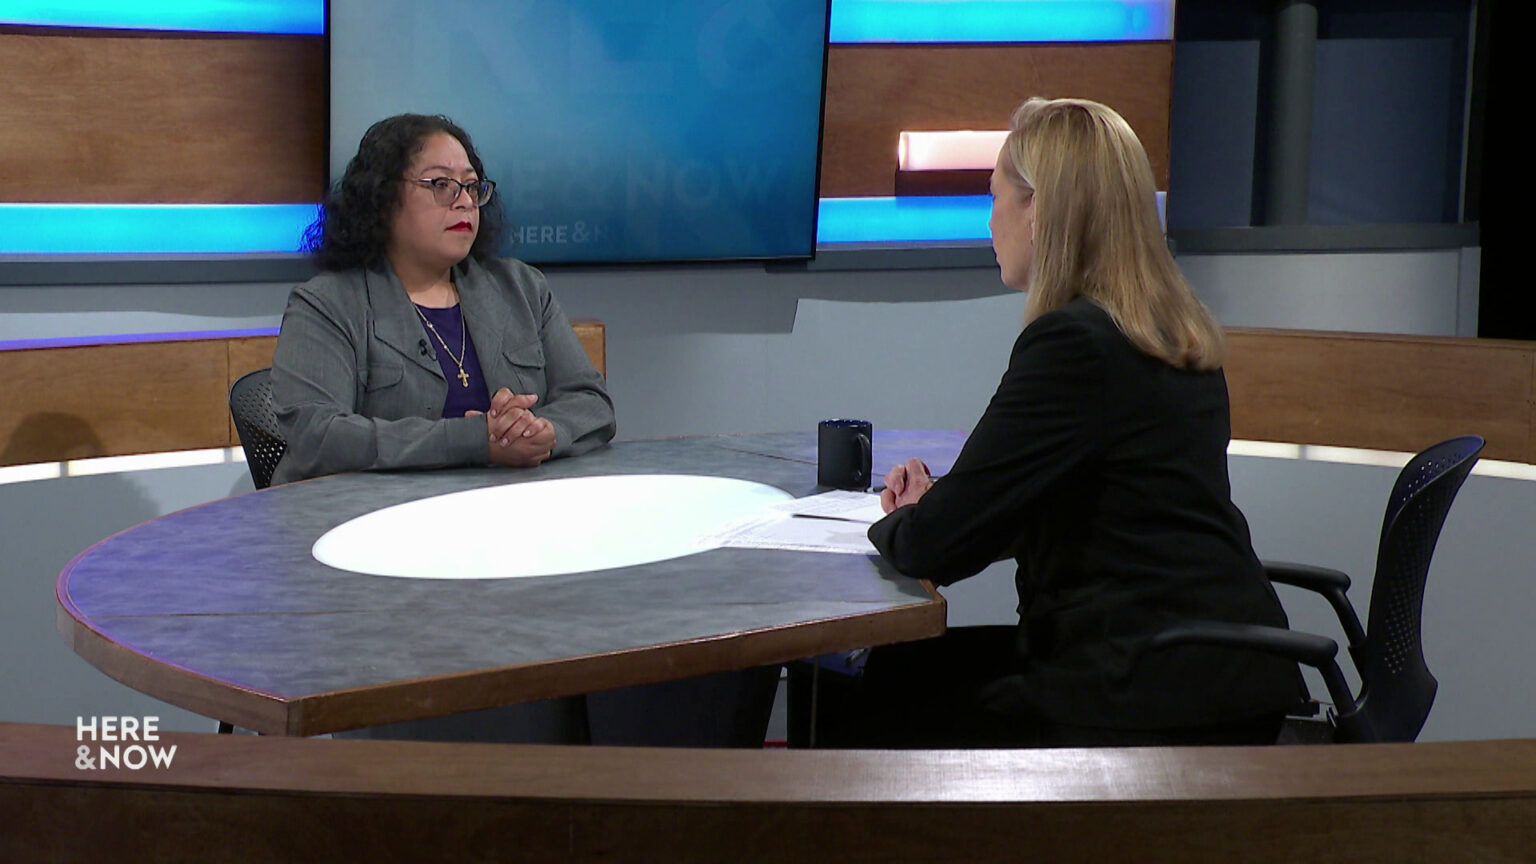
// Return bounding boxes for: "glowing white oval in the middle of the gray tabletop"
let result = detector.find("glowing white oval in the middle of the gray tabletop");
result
[312,474,793,580]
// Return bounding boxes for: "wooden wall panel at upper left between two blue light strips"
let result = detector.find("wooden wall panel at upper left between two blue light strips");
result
[0,28,329,203]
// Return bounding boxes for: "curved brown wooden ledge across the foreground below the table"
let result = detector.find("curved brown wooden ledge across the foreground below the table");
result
[0,724,1536,864]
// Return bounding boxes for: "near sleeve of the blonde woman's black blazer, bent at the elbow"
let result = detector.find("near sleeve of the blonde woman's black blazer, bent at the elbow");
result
[869,314,1106,584]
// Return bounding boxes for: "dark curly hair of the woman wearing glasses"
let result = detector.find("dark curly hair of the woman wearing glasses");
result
[304,114,505,271]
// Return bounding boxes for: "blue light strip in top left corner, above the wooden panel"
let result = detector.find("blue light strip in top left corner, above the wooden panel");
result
[0,0,326,35]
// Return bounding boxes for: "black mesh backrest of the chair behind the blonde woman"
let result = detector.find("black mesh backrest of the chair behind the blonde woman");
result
[1339,435,1484,741]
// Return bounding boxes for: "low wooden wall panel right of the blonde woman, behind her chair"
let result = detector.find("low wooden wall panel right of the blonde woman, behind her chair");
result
[1227,329,1536,463]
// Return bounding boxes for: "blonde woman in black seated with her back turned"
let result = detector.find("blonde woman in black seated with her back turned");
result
[847,98,1299,747]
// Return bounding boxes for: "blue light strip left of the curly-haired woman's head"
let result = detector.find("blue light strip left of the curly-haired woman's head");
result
[0,203,316,255]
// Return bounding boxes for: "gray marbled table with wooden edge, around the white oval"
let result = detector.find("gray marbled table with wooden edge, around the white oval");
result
[57,432,963,735]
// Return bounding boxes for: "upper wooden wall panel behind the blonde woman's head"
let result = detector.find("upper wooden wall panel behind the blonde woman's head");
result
[822,42,1174,197]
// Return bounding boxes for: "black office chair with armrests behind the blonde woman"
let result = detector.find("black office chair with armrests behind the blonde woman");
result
[1147,435,1484,743]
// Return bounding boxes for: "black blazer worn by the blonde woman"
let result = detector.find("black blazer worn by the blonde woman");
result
[869,298,1298,729]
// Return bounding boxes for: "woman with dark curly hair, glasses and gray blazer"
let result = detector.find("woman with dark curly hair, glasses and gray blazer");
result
[272,114,614,483]
